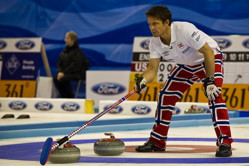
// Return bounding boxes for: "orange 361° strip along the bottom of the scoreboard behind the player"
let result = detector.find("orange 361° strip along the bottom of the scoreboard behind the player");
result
[128,83,249,110]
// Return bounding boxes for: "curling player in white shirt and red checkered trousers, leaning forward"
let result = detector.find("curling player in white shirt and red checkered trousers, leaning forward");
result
[134,5,233,157]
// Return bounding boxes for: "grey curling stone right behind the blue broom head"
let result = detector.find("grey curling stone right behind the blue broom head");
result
[48,140,80,163]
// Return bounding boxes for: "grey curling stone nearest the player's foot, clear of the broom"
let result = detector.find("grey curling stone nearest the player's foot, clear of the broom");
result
[94,133,125,156]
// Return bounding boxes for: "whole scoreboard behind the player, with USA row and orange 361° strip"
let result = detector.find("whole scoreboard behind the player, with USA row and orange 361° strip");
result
[128,36,249,110]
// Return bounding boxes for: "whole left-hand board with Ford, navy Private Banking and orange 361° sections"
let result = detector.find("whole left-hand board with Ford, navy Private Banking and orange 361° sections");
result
[0,38,41,97]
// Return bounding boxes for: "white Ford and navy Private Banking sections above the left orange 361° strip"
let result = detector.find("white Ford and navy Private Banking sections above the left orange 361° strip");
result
[0,38,41,80]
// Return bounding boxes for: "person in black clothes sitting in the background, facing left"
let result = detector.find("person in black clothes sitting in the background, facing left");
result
[53,31,85,98]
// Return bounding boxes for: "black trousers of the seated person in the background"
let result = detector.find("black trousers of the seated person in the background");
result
[53,74,79,98]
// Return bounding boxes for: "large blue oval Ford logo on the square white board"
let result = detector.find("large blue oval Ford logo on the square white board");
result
[92,83,126,95]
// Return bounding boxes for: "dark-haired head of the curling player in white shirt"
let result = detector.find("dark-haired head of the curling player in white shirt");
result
[145,6,172,37]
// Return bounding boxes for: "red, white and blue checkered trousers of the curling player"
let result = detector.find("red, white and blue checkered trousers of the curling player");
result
[150,51,233,148]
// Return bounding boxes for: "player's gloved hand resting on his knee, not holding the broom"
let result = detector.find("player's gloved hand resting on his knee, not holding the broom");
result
[204,77,221,101]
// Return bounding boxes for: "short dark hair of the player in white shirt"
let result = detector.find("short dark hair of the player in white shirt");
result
[145,5,172,26]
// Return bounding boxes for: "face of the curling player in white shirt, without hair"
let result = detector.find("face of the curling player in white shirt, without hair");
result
[147,17,169,37]
